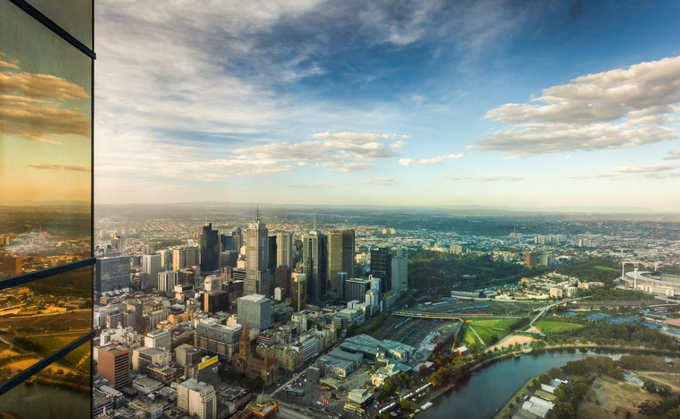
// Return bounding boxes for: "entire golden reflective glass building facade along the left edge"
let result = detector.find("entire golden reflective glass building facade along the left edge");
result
[0,0,95,418]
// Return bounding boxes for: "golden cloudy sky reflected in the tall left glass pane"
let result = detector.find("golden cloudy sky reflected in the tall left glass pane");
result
[0,2,92,206]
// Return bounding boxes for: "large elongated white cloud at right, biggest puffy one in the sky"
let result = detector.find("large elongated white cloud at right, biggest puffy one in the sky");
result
[468,57,680,157]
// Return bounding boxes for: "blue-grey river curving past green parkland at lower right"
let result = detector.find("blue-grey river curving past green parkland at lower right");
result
[416,351,620,419]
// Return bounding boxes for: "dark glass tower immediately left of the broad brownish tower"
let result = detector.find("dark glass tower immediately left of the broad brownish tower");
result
[302,231,328,303]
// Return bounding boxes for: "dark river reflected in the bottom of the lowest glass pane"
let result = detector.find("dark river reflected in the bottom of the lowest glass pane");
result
[0,383,92,419]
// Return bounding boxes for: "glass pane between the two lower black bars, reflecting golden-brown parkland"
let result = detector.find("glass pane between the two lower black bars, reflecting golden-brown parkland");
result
[0,267,92,383]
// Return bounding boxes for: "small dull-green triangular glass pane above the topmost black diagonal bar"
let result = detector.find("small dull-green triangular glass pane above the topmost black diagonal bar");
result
[28,0,92,49]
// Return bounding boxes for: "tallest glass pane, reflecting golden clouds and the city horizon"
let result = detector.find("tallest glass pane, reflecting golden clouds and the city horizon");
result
[0,1,92,279]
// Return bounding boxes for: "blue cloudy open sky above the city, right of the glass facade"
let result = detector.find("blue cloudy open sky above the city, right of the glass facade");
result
[95,0,680,212]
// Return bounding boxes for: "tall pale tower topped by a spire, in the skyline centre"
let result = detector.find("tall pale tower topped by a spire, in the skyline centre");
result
[243,209,271,296]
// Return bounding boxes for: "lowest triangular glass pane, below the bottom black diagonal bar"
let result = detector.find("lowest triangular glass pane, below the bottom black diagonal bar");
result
[0,342,91,419]
